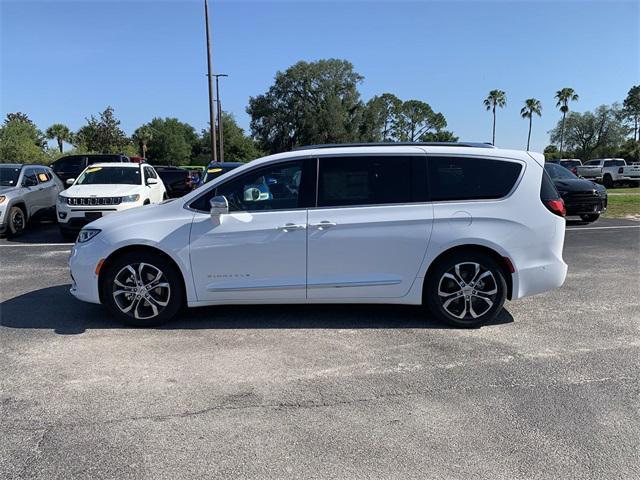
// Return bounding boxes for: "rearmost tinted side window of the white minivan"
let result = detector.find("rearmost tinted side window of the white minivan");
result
[428,157,522,201]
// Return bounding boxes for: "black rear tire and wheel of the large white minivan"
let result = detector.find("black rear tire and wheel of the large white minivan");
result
[424,250,507,328]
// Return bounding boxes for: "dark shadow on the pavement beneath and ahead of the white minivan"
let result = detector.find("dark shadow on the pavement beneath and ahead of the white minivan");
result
[0,285,513,335]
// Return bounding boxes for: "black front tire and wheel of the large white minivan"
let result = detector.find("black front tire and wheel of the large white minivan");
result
[102,250,184,327]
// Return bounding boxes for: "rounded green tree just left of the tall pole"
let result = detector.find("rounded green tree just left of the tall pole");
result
[147,118,198,165]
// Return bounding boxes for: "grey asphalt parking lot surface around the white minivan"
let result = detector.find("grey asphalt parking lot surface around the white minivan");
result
[0,219,640,479]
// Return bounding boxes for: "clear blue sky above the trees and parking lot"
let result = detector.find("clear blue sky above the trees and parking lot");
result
[0,0,640,151]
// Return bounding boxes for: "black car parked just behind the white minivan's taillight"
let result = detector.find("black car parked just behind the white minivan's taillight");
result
[544,163,608,222]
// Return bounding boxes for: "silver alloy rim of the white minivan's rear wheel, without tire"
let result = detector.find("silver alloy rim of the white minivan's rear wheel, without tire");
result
[438,262,498,320]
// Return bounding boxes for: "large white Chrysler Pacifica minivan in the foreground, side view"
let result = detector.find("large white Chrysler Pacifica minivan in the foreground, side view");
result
[69,144,567,327]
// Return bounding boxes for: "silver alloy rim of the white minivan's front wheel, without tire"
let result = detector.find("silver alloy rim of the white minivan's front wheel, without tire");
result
[113,263,171,320]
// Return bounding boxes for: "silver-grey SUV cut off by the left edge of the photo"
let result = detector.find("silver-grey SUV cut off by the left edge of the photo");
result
[0,163,64,235]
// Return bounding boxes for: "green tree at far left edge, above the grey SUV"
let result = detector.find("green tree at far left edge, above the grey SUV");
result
[0,112,48,163]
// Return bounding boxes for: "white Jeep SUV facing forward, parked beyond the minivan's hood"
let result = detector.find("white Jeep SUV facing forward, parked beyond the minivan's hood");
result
[56,163,167,239]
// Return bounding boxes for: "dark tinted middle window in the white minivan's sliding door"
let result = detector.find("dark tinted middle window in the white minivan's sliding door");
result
[318,156,427,207]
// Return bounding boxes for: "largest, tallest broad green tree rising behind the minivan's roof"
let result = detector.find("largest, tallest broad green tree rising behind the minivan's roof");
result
[247,59,363,153]
